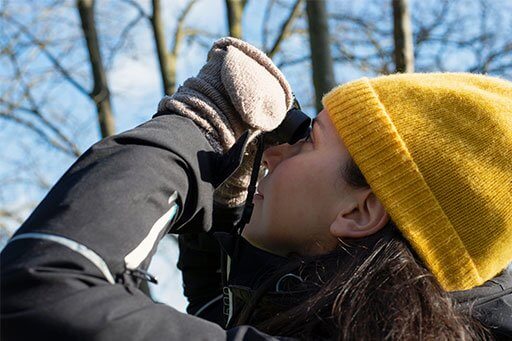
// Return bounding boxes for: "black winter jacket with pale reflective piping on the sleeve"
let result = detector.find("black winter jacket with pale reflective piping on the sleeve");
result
[0,115,512,340]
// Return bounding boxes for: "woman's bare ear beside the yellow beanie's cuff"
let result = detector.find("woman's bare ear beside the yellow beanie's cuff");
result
[330,189,389,238]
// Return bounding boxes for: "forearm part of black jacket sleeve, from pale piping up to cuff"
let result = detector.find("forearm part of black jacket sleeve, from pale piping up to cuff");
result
[14,115,214,277]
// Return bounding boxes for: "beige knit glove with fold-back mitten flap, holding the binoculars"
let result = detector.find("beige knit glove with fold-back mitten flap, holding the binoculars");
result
[158,37,293,207]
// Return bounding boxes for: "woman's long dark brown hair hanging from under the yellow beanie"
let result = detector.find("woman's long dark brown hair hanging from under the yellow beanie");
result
[238,161,490,340]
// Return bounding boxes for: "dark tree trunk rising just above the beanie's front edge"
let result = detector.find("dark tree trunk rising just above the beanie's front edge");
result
[306,0,336,111]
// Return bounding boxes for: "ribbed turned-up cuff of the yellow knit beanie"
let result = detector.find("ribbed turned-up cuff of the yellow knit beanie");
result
[323,78,490,290]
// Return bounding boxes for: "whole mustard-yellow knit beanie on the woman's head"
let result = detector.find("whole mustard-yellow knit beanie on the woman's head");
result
[323,73,512,291]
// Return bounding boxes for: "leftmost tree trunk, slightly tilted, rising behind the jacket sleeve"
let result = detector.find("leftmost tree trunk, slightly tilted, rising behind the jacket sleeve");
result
[77,0,115,137]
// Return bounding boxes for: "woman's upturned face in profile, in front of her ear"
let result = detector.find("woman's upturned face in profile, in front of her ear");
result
[243,109,360,256]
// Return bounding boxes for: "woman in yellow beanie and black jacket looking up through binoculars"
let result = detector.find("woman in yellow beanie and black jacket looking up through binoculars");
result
[1,38,511,340]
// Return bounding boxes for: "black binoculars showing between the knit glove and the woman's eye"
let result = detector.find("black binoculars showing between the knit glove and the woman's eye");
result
[263,99,311,146]
